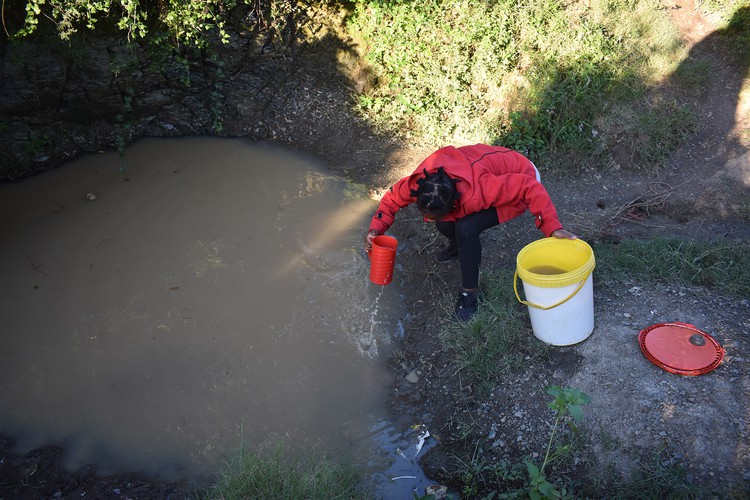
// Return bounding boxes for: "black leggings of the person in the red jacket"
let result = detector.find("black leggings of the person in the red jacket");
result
[435,208,500,290]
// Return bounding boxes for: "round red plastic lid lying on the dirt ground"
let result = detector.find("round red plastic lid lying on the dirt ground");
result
[638,322,724,375]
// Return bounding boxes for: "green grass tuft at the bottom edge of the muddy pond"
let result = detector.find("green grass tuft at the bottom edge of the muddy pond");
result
[202,444,367,500]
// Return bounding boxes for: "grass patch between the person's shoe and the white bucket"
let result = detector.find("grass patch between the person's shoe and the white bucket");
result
[440,271,548,399]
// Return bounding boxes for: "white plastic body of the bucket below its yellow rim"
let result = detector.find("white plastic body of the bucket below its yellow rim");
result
[523,274,594,346]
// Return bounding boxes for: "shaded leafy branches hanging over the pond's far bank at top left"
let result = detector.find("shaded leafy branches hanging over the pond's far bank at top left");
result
[0,0,312,180]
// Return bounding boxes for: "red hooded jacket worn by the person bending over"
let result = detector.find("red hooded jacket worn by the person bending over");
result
[370,144,562,236]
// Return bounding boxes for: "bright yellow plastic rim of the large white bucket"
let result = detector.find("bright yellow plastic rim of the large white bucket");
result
[516,237,596,288]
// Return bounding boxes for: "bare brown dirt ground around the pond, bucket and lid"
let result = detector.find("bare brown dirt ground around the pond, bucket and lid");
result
[0,1,750,499]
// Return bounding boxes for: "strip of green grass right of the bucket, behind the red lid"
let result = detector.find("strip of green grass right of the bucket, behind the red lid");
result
[594,238,750,298]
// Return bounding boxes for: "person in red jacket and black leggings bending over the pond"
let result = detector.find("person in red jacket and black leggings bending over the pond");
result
[365,144,577,321]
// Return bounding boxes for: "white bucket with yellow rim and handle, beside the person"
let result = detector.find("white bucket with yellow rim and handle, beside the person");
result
[513,238,596,346]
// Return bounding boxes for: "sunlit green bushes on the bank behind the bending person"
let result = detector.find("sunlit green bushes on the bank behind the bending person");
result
[350,0,748,168]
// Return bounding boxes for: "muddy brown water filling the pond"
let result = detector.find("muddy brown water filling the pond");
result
[0,138,434,492]
